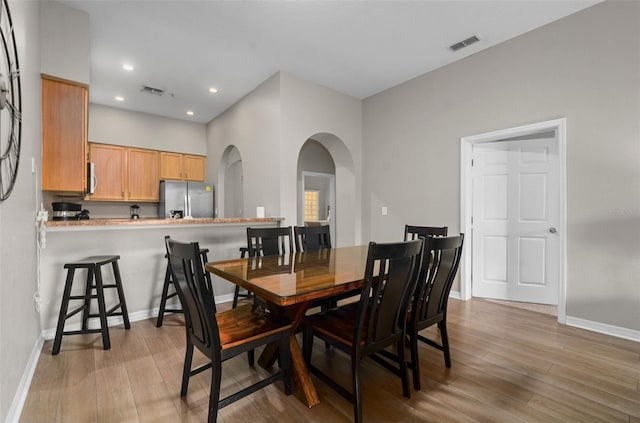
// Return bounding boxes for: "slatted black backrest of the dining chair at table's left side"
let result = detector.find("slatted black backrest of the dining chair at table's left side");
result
[165,237,221,361]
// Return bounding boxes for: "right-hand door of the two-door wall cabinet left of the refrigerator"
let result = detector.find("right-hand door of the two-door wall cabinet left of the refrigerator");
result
[127,148,160,201]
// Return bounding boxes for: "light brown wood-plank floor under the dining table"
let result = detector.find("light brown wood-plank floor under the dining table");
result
[20,299,640,423]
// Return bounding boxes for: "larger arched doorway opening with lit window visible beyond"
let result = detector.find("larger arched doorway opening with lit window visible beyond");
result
[297,138,338,243]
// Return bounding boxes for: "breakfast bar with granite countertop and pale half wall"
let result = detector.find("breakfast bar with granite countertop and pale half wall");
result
[35,217,283,339]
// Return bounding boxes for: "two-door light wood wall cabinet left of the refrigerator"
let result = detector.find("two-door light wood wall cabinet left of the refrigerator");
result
[87,143,160,202]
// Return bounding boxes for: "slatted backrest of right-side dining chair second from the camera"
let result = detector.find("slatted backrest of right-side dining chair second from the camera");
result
[410,234,464,327]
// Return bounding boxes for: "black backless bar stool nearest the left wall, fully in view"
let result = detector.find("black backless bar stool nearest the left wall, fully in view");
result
[52,256,131,355]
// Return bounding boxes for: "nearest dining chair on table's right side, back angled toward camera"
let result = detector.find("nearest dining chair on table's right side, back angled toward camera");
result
[303,239,423,423]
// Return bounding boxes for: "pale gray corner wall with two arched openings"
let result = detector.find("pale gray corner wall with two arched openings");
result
[207,72,361,245]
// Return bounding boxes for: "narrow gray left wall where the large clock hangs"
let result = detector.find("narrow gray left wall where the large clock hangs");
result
[0,1,42,421]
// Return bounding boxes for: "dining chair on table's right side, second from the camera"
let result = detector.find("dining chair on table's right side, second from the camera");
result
[407,234,464,390]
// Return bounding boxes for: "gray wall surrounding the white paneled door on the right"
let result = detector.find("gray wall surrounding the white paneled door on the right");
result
[362,1,640,330]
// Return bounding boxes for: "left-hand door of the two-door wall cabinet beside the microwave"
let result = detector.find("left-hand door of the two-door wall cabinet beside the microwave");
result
[88,144,126,201]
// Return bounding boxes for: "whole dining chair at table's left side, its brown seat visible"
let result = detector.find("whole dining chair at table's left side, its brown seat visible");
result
[166,238,292,423]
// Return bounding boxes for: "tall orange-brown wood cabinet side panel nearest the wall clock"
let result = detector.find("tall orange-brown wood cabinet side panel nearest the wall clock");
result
[42,76,88,194]
